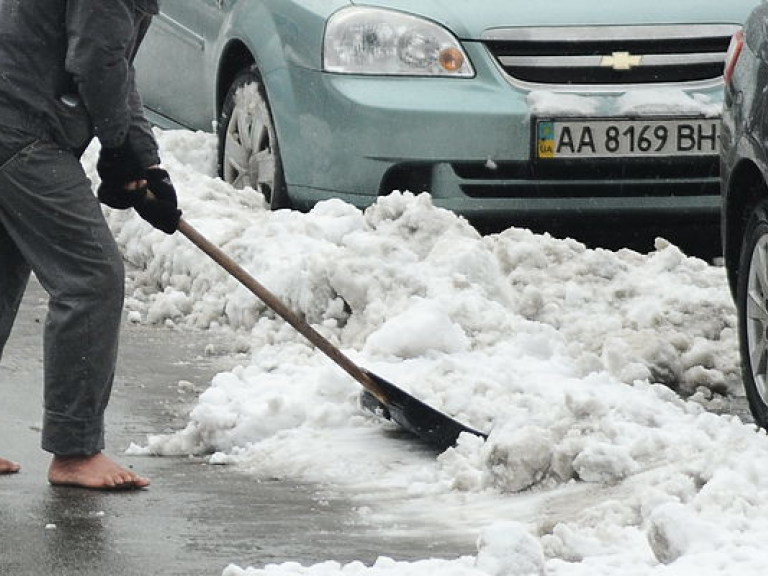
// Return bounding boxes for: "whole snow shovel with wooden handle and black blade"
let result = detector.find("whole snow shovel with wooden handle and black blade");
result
[179,218,488,452]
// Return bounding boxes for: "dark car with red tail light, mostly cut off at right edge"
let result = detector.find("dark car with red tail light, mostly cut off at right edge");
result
[720,3,768,428]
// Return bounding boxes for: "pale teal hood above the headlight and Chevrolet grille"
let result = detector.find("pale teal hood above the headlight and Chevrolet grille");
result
[352,0,760,40]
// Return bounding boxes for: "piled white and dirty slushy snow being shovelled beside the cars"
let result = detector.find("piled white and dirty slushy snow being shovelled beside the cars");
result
[84,132,768,576]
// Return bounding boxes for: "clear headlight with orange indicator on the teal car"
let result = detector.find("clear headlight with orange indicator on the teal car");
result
[323,7,475,78]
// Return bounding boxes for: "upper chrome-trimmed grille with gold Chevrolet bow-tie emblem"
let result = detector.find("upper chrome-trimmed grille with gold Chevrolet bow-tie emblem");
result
[482,24,738,85]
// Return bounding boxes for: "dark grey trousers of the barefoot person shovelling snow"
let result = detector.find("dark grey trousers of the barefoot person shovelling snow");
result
[0,129,124,456]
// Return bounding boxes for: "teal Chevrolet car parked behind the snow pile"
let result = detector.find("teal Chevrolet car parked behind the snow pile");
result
[136,0,759,221]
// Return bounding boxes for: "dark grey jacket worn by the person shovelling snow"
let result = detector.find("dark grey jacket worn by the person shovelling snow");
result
[0,0,159,166]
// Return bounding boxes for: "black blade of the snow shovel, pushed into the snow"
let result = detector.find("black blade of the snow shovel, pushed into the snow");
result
[361,370,488,452]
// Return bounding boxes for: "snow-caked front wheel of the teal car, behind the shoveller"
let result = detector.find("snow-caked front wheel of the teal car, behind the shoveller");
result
[217,68,290,210]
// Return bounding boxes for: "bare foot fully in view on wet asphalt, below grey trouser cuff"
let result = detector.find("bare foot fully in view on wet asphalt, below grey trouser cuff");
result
[48,452,149,490]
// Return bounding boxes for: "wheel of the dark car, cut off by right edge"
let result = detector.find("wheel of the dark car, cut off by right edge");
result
[736,200,768,428]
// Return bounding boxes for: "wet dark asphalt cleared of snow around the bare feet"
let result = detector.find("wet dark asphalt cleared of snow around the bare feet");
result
[0,282,474,576]
